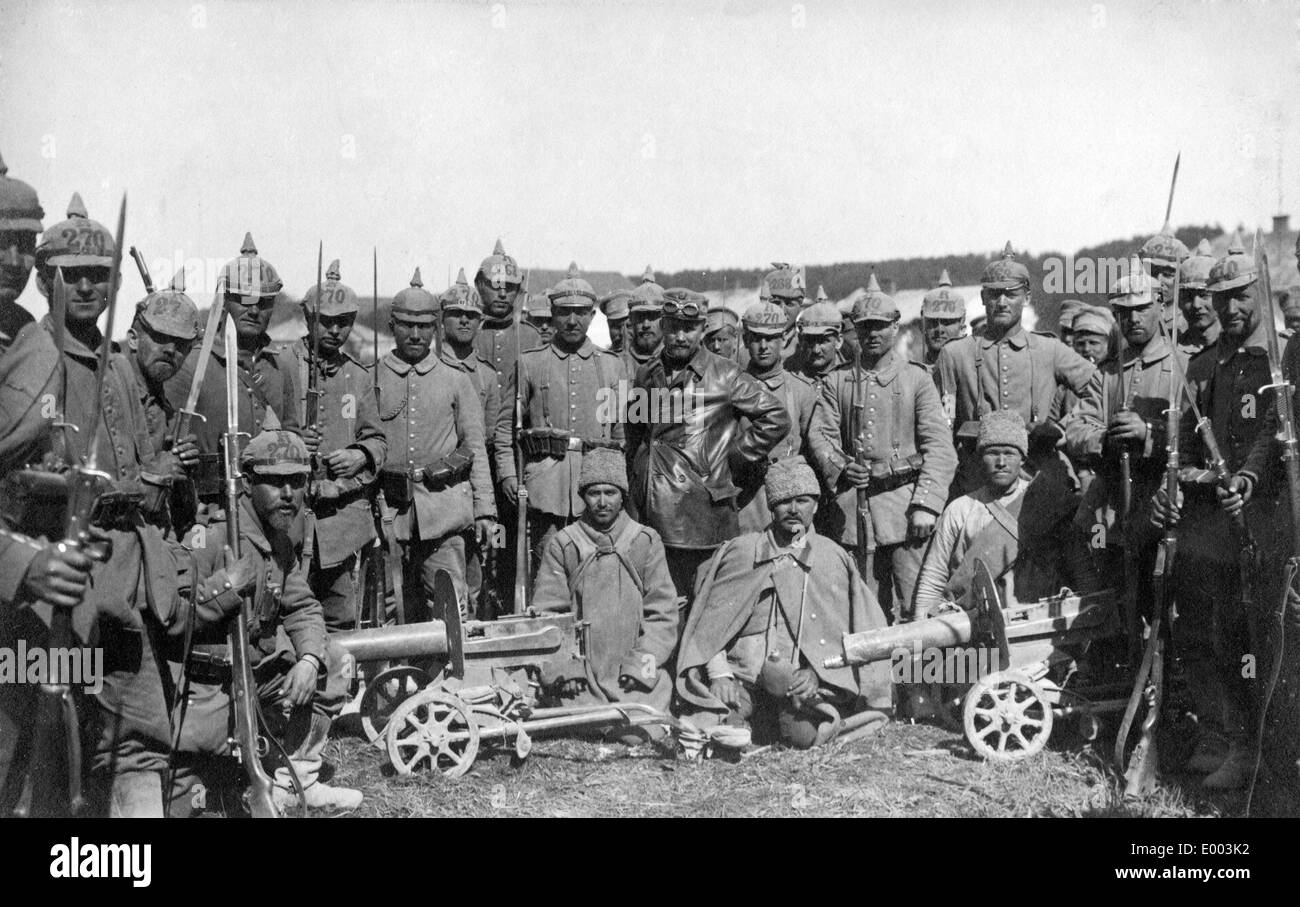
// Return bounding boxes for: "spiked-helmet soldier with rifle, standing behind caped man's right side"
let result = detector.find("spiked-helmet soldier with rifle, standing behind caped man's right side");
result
[809,274,957,620]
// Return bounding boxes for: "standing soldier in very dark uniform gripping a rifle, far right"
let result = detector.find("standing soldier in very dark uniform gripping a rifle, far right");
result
[1153,234,1274,789]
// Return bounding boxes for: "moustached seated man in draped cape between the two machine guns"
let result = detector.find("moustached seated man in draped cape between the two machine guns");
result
[677,456,891,748]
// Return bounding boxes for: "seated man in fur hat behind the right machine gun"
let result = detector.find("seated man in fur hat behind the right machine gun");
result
[914,409,1100,619]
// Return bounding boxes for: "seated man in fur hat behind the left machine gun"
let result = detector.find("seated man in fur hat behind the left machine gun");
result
[533,450,679,737]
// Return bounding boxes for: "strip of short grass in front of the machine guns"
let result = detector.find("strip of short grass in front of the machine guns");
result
[314,724,1289,817]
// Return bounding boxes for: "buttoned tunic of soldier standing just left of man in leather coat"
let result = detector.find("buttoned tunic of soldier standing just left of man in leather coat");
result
[497,339,624,521]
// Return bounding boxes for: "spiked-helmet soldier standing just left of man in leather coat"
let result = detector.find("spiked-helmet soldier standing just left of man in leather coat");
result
[497,262,624,569]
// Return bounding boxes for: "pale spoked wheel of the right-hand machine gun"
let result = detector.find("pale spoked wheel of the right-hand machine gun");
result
[962,671,1052,761]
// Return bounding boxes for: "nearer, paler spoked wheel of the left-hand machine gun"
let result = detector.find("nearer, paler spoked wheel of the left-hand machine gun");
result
[386,690,478,778]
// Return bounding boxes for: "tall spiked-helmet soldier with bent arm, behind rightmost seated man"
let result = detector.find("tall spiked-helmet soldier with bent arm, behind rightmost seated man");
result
[933,243,1095,494]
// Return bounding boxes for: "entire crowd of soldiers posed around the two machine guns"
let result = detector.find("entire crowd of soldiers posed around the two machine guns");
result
[0,144,1300,816]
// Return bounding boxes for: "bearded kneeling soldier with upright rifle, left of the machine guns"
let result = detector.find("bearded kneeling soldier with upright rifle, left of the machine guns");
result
[172,426,361,810]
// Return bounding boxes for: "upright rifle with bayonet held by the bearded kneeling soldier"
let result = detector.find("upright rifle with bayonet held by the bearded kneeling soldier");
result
[221,309,280,819]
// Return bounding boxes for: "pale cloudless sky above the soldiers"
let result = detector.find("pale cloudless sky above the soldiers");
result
[0,0,1300,318]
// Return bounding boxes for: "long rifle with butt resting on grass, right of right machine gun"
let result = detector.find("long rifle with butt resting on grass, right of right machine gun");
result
[1115,252,1183,797]
